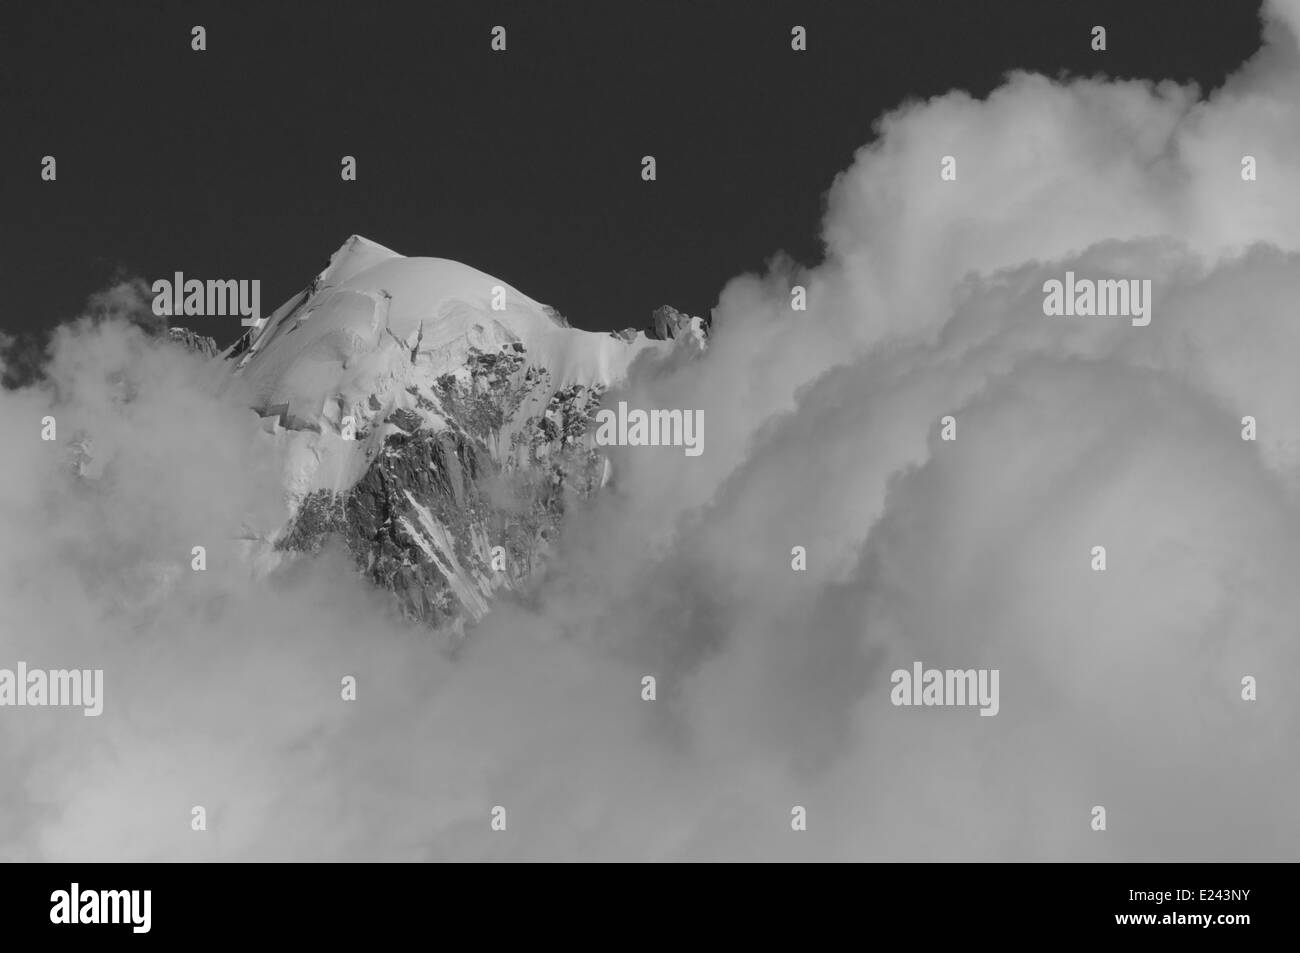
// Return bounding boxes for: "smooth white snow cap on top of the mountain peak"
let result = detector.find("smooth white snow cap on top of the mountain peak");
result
[228,235,658,434]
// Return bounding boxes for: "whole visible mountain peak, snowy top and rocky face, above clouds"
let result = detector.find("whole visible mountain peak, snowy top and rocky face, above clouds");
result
[225,235,705,633]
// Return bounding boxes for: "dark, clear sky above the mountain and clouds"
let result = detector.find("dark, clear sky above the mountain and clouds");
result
[0,0,1258,343]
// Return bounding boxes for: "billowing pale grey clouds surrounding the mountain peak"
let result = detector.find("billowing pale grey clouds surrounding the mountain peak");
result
[0,0,1300,861]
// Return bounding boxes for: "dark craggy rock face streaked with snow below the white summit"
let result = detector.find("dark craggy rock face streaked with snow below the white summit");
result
[277,343,603,640]
